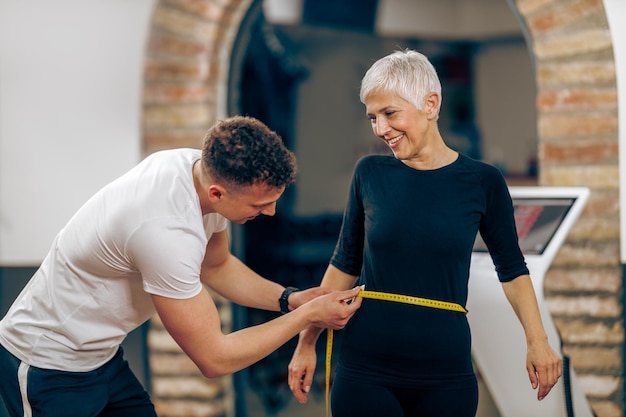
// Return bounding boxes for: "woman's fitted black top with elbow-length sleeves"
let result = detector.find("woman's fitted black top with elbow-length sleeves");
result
[331,155,528,387]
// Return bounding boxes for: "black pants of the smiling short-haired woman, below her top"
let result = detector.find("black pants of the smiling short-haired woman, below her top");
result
[330,369,478,417]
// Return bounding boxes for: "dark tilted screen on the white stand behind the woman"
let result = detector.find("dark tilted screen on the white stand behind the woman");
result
[474,198,576,255]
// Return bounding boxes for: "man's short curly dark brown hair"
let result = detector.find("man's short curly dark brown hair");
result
[202,116,297,188]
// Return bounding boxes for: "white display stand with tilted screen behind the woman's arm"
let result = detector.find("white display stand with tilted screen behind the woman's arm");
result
[467,187,593,417]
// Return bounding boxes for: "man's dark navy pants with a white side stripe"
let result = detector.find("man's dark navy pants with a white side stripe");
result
[0,345,156,417]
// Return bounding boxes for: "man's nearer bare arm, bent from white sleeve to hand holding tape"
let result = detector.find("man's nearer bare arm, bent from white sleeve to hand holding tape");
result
[152,278,361,378]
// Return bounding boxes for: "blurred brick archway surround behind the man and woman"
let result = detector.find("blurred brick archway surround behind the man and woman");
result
[143,0,624,417]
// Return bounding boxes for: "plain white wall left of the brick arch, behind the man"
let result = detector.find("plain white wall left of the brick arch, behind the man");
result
[0,0,155,266]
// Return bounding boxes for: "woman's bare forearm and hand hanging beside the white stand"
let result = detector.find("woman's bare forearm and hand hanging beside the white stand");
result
[502,275,563,400]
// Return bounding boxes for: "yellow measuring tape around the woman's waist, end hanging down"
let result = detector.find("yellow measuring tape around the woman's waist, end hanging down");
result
[326,290,467,417]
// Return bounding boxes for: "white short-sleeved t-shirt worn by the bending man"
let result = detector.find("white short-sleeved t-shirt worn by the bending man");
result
[0,149,227,371]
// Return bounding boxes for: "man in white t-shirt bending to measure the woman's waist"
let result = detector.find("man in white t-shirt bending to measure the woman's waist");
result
[0,116,361,417]
